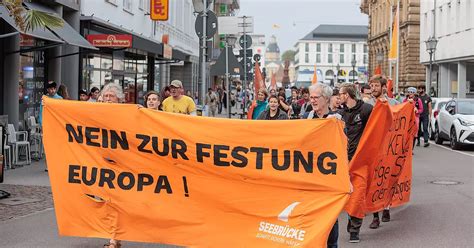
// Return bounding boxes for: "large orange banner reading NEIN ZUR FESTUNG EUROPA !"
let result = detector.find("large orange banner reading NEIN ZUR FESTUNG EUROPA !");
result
[43,98,350,247]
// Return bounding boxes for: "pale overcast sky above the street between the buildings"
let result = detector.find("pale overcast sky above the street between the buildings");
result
[238,0,368,54]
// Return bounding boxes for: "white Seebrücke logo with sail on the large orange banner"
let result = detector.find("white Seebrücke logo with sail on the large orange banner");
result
[257,202,306,246]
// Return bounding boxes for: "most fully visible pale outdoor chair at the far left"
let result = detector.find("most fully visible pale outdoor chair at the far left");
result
[7,124,31,165]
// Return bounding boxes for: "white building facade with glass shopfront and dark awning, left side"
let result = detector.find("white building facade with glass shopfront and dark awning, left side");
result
[80,0,199,103]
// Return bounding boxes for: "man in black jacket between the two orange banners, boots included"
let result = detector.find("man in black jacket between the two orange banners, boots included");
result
[339,83,372,243]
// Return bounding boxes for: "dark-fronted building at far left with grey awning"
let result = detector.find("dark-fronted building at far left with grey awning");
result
[0,0,90,128]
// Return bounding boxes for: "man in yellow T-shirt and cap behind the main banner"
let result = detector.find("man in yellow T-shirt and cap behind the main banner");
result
[162,80,196,115]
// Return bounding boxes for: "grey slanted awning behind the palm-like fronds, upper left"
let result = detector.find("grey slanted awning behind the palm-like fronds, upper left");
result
[25,2,98,50]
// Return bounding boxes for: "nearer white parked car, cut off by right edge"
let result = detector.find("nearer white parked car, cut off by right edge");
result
[435,99,474,150]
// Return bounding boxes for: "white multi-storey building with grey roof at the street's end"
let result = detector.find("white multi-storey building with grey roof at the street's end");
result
[295,25,368,86]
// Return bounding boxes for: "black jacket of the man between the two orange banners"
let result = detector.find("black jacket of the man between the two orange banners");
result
[341,100,373,161]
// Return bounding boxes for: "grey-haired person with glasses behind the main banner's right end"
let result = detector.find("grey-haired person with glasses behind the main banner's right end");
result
[304,83,342,248]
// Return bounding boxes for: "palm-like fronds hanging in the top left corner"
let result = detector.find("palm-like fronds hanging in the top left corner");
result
[0,0,63,33]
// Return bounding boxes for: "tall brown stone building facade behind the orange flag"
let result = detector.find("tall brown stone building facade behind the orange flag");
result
[360,0,425,89]
